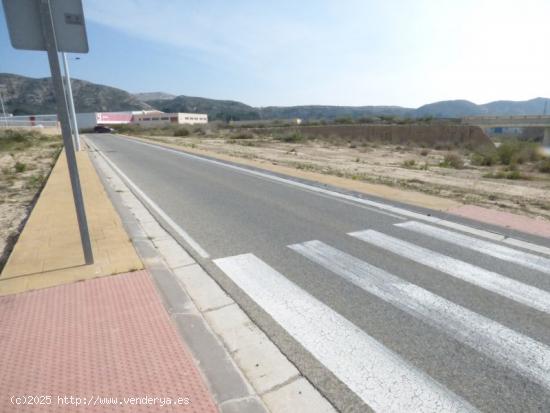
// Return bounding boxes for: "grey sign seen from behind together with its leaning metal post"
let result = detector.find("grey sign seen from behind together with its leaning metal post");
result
[3,0,94,264]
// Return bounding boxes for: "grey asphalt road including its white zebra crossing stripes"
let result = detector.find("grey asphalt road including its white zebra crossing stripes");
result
[88,134,550,412]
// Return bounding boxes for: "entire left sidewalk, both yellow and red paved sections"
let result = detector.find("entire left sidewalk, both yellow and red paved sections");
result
[0,152,218,412]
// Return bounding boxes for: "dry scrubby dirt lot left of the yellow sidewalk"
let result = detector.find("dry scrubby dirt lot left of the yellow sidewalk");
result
[0,130,61,270]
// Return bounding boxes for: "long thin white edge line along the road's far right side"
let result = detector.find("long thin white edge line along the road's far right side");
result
[113,137,550,255]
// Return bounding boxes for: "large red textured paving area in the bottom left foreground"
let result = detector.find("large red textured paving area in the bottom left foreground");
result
[0,271,218,413]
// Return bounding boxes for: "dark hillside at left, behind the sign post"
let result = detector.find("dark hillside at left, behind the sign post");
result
[0,73,151,115]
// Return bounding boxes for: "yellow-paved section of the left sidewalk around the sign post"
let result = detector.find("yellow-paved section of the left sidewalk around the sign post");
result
[0,152,143,295]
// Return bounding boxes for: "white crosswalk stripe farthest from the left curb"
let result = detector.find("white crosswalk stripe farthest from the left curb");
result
[395,221,550,273]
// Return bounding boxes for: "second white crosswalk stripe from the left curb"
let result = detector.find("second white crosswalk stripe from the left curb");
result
[289,241,550,389]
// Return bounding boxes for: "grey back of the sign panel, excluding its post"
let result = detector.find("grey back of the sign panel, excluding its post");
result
[2,0,88,53]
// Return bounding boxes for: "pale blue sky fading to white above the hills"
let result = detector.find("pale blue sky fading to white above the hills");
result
[0,0,550,107]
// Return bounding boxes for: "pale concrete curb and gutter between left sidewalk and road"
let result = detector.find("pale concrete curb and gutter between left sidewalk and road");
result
[88,141,335,413]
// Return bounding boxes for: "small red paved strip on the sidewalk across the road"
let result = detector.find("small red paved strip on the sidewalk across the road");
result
[448,205,550,237]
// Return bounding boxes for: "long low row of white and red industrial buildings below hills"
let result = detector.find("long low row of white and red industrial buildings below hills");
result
[0,110,208,130]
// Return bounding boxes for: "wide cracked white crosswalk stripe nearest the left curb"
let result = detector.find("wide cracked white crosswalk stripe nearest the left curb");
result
[214,254,475,413]
